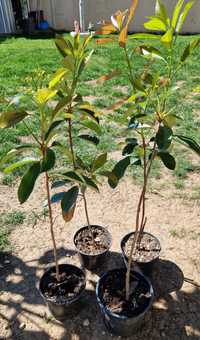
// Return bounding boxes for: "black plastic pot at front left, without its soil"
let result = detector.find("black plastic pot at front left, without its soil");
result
[39,264,86,321]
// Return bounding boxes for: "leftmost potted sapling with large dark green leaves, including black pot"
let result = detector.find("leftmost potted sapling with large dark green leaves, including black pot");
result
[0,72,86,319]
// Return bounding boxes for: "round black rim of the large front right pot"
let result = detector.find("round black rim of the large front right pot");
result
[96,268,155,320]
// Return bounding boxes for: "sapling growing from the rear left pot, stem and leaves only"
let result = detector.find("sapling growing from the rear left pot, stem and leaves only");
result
[53,32,107,245]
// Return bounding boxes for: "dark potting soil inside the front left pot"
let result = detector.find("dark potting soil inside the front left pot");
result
[43,272,85,304]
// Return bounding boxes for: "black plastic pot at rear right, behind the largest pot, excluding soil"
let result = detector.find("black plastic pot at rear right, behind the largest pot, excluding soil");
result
[120,232,161,275]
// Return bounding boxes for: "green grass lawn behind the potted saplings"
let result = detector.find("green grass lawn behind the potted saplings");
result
[0,36,200,187]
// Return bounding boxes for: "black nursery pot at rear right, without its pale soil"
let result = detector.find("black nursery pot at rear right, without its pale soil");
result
[120,232,161,275]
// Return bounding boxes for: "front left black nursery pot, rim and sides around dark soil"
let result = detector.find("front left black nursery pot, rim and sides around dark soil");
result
[39,264,86,321]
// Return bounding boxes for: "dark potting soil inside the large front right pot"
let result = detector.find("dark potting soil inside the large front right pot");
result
[102,271,151,317]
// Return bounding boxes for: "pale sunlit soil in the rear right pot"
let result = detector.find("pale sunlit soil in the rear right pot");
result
[124,233,161,263]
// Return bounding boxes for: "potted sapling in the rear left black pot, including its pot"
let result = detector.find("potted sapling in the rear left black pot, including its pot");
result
[52,33,111,269]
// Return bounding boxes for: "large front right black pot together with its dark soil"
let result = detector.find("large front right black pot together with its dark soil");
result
[96,268,154,336]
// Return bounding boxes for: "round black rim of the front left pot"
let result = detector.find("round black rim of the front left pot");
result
[38,263,86,306]
